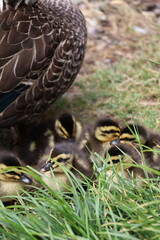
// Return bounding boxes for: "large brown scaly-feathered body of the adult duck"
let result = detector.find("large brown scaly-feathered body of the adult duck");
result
[0,0,86,127]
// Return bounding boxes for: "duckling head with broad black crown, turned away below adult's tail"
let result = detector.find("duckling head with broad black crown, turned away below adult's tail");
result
[55,113,82,139]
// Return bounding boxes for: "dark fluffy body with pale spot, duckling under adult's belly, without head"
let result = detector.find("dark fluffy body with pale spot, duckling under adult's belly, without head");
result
[12,122,54,170]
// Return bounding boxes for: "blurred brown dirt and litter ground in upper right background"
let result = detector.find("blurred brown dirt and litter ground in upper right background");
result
[77,0,160,74]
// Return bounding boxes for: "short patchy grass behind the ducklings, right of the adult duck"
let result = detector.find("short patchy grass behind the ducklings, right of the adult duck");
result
[51,58,160,128]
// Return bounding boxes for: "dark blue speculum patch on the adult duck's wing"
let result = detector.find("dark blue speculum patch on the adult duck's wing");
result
[0,84,29,112]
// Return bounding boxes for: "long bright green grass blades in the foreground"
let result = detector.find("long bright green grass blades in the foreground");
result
[0,160,160,240]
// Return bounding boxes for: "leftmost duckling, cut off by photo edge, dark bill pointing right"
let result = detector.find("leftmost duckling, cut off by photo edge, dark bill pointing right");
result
[0,151,32,202]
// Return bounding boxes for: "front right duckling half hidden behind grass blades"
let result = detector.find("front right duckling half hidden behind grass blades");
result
[107,144,158,186]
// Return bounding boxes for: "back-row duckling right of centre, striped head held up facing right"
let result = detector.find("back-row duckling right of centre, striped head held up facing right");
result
[78,117,120,164]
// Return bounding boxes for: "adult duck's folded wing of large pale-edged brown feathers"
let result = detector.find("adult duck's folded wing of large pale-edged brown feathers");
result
[0,7,55,93]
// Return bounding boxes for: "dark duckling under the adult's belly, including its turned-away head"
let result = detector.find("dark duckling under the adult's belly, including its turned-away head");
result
[13,113,82,170]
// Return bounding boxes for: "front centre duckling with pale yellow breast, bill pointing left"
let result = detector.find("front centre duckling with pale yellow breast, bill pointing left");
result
[41,142,88,192]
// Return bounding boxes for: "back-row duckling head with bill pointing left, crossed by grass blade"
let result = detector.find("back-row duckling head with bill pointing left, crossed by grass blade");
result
[111,124,147,145]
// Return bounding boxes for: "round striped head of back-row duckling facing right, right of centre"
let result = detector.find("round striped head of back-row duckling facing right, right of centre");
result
[95,118,120,142]
